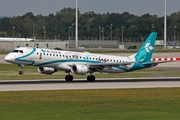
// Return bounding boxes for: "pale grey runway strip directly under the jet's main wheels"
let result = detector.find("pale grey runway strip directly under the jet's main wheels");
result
[0,77,180,91]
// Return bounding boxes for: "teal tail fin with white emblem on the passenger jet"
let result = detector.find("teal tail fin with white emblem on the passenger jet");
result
[134,32,157,62]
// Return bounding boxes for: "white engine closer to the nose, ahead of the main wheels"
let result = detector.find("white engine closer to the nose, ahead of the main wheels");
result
[38,67,57,74]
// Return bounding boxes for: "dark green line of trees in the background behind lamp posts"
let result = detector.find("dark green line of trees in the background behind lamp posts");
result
[0,8,180,40]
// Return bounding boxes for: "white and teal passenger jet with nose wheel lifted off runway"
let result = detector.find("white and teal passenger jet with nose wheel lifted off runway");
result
[4,32,171,81]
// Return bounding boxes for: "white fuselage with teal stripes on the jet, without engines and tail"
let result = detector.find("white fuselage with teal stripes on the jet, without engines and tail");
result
[5,47,134,73]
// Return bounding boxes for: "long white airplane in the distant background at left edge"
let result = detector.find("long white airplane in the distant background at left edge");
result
[0,37,34,42]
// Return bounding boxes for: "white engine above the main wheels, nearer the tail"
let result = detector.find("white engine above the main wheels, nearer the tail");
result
[71,65,88,75]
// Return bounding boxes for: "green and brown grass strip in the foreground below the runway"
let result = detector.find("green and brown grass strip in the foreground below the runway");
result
[0,88,180,120]
